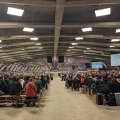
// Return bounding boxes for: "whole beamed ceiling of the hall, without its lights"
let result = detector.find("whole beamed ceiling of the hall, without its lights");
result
[0,0,120,66]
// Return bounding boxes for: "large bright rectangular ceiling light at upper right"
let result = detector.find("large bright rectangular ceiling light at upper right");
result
[95,8,111,17]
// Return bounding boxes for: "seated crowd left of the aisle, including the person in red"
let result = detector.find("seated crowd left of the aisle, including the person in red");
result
[0,73,53,106]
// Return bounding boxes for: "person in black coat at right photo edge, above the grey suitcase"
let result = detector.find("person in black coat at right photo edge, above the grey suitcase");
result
[108,78,120,93]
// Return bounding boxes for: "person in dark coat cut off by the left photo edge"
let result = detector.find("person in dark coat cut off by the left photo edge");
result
[0,76,9,94]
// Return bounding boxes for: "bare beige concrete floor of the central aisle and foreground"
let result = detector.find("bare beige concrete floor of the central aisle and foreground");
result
[0,75,120,120]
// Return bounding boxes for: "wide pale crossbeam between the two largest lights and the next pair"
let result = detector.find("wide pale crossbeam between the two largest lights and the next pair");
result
[0,22,120,29]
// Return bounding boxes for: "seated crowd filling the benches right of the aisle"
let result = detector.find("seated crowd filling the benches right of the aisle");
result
[58,71,120,105]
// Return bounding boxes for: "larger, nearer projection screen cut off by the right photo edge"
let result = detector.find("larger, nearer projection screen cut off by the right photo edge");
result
[111,53,120,66]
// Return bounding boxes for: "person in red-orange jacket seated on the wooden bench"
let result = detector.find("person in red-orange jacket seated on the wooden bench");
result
[24,78,37,106]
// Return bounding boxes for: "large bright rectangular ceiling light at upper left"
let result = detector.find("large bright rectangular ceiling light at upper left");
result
[7,7,24,16]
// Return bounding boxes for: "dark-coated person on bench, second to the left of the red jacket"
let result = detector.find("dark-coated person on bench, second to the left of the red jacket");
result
[8,76,22,95]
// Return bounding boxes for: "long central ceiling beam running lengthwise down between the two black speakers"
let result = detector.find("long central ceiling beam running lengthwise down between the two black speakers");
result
[53,0,66,66]
